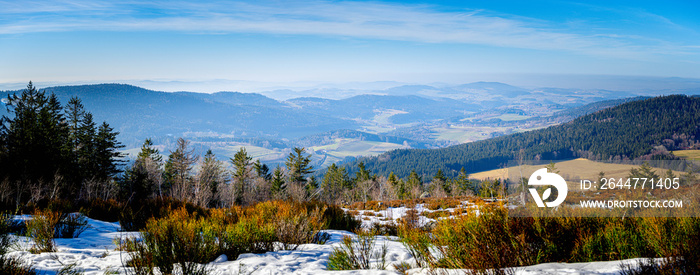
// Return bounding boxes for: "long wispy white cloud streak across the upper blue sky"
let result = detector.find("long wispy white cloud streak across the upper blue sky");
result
[0,0,688,58]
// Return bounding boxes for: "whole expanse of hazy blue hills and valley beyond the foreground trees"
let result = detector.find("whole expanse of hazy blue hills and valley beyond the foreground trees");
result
[0,82,696,168]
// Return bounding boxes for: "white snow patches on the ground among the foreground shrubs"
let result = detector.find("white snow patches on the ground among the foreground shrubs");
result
[4,216,652,275]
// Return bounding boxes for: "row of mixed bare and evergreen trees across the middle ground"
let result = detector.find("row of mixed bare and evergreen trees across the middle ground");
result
[122,138,505,207]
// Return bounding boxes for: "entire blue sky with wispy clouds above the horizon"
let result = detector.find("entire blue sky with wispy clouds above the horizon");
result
[0,0,700,92]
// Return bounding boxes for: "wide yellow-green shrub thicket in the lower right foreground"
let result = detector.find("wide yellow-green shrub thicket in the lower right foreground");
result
[399,207,700,274]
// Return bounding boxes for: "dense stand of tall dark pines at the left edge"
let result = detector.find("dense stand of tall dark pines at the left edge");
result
[0,82,123,207]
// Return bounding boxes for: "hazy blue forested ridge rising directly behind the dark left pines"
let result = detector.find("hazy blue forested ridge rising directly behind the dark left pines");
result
[1,84,356,144]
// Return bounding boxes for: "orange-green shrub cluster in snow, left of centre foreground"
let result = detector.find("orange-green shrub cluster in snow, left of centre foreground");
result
[124,201,357,274]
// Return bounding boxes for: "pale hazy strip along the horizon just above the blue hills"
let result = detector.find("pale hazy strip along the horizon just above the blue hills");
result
[0,74,700,100]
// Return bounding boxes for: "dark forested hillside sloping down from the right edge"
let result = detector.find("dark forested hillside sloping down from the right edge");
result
[347,95,700,177]
